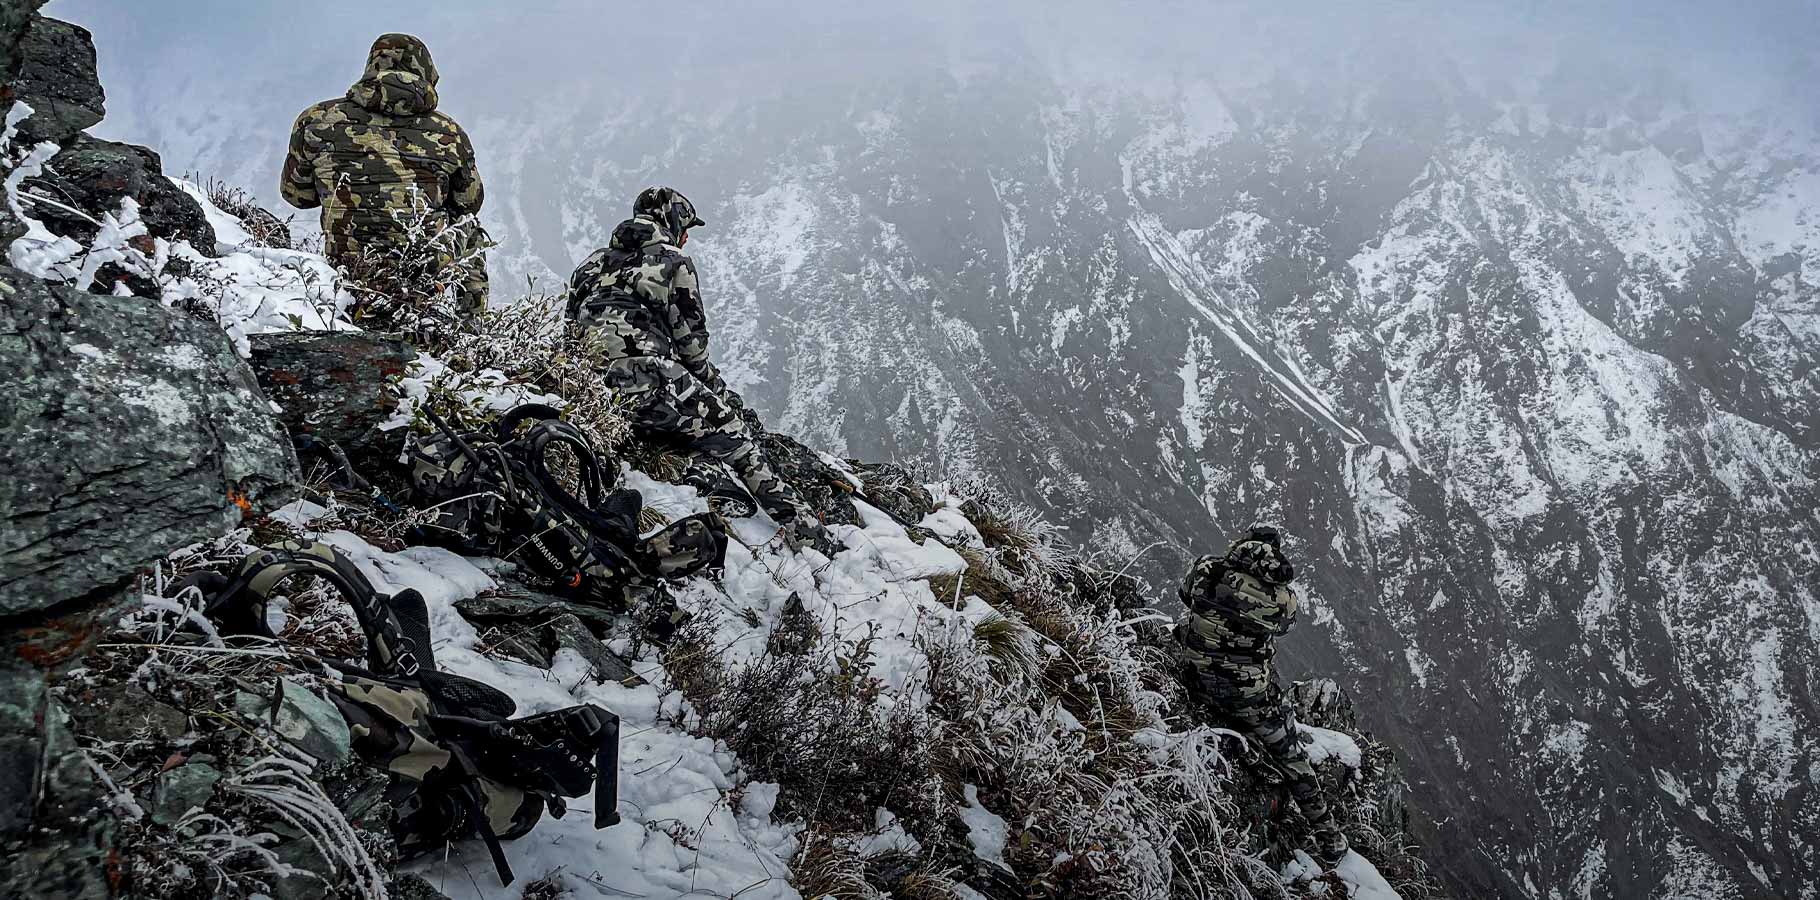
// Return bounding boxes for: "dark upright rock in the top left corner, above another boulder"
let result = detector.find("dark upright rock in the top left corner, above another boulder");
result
[13,15,107,145]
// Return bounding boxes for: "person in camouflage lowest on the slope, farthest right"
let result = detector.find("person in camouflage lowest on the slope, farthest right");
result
[1176,527,1347,865]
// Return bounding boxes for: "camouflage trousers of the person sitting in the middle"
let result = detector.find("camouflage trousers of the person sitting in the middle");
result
[606,356,815,524]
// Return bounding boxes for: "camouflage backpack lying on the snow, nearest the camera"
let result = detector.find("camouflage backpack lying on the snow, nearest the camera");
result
[178,542,619,884]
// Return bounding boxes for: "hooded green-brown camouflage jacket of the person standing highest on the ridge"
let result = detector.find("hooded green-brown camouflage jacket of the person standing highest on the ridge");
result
[278,35,484,255]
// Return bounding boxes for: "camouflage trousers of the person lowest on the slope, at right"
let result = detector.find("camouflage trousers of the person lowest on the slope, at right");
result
[1188,660,1347,860]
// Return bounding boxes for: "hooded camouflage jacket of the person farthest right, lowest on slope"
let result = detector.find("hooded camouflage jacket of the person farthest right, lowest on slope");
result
[1176,540,1298,667]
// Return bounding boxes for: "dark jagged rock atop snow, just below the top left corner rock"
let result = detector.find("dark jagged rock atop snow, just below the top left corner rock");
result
[24,135,215,256]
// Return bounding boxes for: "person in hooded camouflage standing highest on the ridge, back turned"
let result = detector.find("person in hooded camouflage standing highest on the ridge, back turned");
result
[278,35,486,316]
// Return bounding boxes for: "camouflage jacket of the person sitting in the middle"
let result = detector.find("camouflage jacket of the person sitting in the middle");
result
[568,216,724,391]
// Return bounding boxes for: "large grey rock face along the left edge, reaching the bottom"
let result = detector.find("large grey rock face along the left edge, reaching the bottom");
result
[0,269,297,896]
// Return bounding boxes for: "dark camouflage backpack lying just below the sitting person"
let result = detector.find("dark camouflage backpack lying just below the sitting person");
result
[411,404,726,600]
